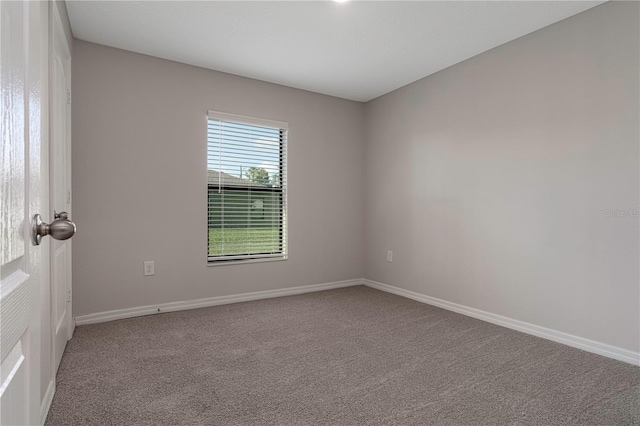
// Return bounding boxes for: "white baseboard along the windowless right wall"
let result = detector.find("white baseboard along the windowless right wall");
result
[363,279,640,365]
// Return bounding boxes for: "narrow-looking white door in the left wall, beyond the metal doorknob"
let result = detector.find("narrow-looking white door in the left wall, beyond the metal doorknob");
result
[49,7,73,372]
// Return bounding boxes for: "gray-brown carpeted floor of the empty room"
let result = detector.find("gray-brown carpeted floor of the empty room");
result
[46,286,640,425]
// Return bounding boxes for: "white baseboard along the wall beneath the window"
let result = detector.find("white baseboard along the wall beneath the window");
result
[75,279,363,325]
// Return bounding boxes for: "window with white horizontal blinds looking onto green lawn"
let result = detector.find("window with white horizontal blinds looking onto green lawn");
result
[207,111,287,265]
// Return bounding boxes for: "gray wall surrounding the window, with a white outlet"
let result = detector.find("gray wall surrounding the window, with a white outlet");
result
[73,40,364,316]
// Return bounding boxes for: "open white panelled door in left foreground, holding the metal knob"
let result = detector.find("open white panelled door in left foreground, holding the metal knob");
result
[0,1,48,425]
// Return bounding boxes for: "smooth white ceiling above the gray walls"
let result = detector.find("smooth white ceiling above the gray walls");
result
[67,1,604,101]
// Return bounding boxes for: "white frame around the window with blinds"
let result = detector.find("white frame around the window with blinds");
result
[207,111,289,266]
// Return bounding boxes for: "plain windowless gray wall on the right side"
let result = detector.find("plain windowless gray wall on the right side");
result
[365,2,640,351]
